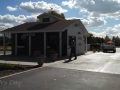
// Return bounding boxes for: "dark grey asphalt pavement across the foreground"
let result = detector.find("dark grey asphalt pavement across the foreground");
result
[0,67,120,90]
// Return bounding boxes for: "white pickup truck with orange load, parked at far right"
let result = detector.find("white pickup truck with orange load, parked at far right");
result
[102,41,116,53]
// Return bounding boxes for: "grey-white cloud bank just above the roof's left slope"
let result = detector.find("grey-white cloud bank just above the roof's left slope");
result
[0,14,37,28]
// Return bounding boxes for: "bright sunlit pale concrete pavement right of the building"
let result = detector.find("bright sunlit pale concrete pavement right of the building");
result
[49,48,120,74]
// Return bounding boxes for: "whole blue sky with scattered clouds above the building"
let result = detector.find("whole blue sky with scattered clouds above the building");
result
[0,0,120,37]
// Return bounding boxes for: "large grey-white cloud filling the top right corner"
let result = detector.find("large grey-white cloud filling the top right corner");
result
[62,0,120,19]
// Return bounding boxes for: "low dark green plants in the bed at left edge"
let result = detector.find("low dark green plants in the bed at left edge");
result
[0,63,26,71]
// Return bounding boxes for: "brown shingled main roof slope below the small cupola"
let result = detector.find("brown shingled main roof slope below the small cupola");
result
[1,19,78,33]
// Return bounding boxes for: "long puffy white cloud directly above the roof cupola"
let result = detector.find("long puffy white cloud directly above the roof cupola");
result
[20,1,67,14]
